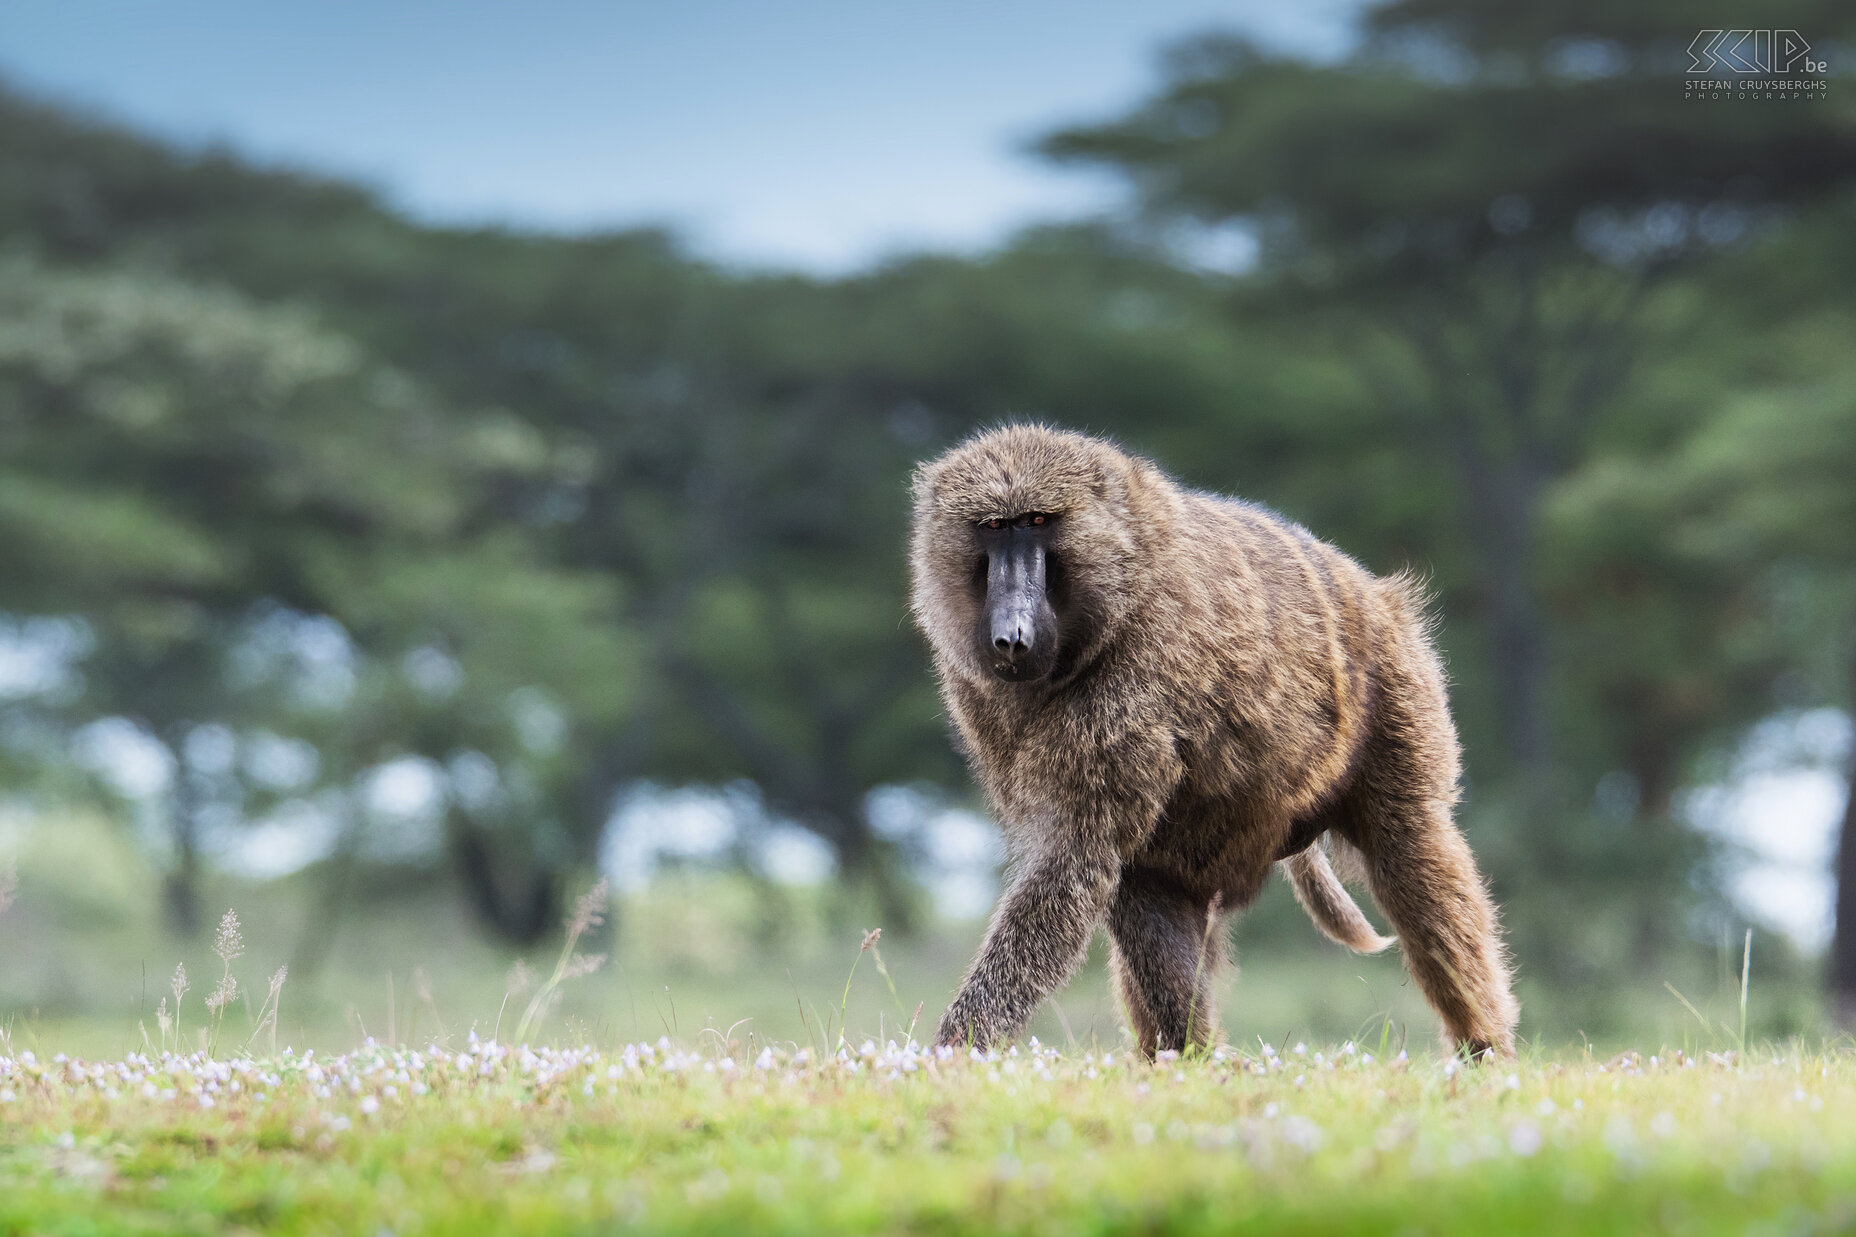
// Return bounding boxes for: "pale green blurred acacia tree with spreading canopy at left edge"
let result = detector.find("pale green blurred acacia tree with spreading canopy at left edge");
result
[0,260,624,931]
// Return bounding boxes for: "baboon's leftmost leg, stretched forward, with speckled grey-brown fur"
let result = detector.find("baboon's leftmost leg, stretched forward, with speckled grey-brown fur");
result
[935,851,1117,1049]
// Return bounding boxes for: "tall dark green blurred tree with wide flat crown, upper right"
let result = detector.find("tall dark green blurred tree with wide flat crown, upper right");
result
[1045,0,1856,782]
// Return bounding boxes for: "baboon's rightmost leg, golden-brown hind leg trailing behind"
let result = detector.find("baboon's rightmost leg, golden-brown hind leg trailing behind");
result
[1355,797,1518,1055]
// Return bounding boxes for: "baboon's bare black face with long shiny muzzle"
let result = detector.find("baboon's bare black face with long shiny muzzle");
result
[973,511,1063,684]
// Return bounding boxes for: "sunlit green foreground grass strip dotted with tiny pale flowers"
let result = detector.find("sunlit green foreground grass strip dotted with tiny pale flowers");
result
[0,1035,1856,1237]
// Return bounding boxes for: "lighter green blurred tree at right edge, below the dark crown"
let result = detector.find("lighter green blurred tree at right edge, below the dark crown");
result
[1557,202,1856,1027]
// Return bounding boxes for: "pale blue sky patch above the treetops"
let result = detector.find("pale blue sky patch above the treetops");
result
[0,0,1359,271]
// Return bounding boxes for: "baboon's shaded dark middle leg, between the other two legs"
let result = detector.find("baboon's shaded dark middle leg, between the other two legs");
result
[1108,867,1223,1057]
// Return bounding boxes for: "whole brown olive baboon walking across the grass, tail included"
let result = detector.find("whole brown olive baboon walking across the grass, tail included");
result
[909,425,1516,1055]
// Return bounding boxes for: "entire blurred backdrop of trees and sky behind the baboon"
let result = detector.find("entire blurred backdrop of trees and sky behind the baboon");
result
[0,0,1856,1051]
